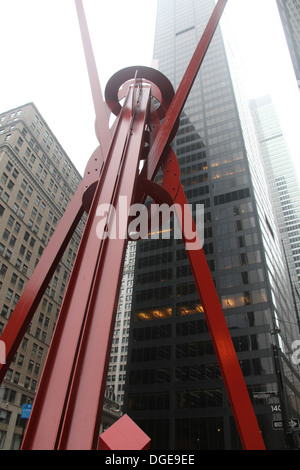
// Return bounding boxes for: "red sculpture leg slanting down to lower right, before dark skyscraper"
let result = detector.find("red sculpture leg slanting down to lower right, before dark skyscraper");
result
[143,142,265,450]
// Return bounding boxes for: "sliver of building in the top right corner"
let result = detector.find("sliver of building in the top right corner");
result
[277,0,300,88]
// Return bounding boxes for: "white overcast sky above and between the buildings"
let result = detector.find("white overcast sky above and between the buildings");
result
[0,0,300,173]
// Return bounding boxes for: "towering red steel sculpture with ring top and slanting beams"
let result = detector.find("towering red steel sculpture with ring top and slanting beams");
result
[0,0,265,450]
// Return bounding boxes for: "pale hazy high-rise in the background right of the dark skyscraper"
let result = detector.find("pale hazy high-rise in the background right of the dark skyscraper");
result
[250,96,300,325]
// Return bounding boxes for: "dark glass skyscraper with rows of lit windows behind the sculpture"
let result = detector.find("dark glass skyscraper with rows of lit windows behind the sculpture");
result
[125,0,300,450]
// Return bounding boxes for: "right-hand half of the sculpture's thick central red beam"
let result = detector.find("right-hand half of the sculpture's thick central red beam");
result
[58,86,150,450]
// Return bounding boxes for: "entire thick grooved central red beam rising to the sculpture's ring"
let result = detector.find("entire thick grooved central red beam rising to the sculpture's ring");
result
[23,82,150,449]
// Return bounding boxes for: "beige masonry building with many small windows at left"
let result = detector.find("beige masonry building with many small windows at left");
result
[0,103,83,450]
